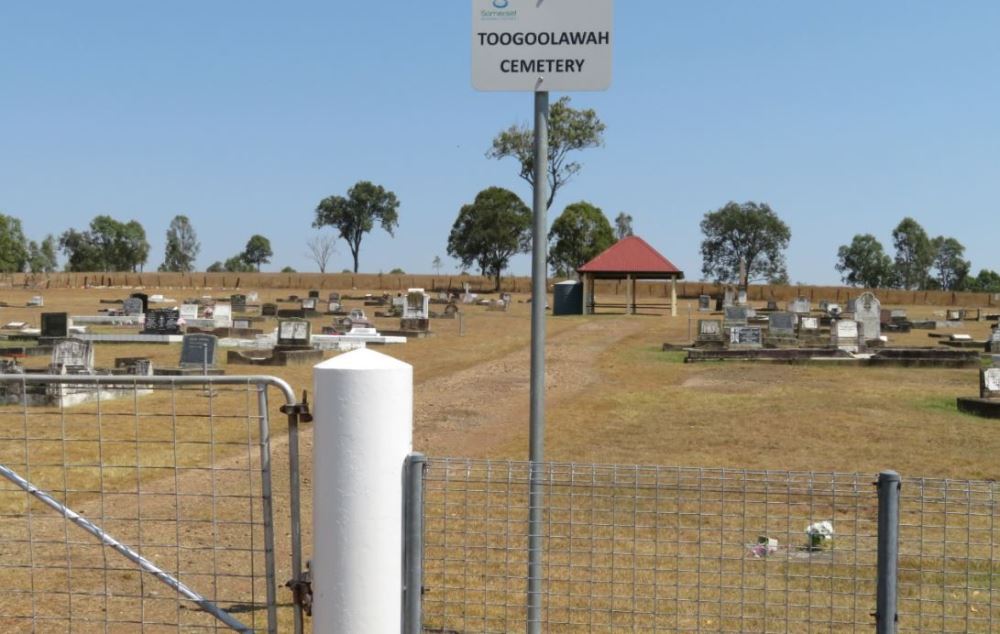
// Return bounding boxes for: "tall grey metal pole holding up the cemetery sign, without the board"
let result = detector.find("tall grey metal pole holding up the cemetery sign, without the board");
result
[527,91,549,634]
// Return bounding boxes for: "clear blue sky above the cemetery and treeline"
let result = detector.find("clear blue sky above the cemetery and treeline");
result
[0,0,1000,283]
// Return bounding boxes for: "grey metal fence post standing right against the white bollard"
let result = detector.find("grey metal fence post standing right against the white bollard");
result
[403,453,427,634]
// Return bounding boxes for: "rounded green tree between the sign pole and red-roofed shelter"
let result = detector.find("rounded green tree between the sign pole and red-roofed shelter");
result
[549,201,615,277]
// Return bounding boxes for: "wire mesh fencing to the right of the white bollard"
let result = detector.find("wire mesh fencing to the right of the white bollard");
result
[423,459,1000,632]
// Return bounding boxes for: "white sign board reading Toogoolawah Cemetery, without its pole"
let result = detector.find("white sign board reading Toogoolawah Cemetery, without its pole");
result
[472,0,612,92]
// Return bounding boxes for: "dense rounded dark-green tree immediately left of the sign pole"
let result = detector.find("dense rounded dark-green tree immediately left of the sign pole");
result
[448,187,532,290]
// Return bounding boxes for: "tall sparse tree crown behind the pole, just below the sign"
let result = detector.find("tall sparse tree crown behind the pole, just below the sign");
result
[486,97,605,209]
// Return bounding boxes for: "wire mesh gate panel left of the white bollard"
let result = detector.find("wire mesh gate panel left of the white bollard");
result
[0,375,296,632]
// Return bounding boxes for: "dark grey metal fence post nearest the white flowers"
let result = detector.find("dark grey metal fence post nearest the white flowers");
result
[875,471,902,634]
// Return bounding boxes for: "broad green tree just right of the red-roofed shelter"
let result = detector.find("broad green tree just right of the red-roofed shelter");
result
[701,201,792,288]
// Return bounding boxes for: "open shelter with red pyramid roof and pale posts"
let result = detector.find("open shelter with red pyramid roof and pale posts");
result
[576,236,684,317]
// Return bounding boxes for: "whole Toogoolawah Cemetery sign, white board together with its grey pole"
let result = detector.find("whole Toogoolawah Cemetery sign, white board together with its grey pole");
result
[472,0,612,634]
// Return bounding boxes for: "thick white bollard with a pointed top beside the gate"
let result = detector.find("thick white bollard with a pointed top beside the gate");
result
[312,349,413,634]
